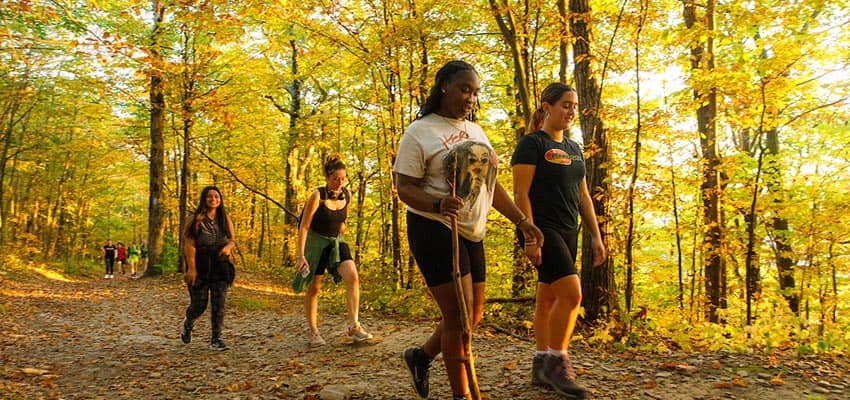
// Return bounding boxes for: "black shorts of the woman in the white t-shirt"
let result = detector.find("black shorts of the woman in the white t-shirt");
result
[407,211,487,287]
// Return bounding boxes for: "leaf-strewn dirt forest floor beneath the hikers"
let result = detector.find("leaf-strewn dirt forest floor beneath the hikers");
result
[0,265,850,400]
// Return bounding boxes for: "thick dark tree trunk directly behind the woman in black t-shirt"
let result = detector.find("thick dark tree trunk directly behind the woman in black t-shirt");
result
[570,0,619,321]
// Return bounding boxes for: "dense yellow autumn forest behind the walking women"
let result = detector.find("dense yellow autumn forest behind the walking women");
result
[0,0,850,353]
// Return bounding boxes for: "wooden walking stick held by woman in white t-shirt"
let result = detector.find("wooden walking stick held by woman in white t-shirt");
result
[451,154,481,400]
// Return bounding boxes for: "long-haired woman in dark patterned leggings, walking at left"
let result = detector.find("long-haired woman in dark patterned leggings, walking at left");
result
[180,186,236,350]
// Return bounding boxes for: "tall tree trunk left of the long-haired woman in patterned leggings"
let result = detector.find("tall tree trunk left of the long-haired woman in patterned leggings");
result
[145,0,166,276]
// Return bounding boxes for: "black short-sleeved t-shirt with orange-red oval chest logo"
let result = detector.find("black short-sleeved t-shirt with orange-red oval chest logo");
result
[511,131,585,231]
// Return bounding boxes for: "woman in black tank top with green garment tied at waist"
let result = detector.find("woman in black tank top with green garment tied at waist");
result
[293,154,372,347]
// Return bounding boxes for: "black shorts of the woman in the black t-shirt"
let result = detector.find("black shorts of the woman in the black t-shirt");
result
[535,228,578,284]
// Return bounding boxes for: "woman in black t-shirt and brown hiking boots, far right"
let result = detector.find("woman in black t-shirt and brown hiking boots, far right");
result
[511,83,606,398]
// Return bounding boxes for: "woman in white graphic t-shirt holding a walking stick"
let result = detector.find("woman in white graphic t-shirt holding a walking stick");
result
[393,61,543,399]
